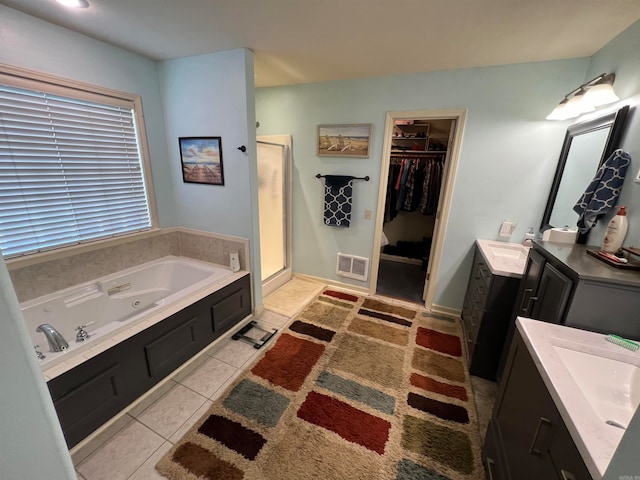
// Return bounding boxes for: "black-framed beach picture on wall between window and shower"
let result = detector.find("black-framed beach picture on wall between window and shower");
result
[178,137,224,185]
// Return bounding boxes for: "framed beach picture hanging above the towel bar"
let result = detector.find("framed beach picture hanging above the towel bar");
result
[317,123,373,158]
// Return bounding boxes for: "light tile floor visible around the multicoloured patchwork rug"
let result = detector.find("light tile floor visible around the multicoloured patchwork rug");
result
[72,299,495,480]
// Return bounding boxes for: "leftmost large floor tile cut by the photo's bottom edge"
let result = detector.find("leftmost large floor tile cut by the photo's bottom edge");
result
[77,421,164,480]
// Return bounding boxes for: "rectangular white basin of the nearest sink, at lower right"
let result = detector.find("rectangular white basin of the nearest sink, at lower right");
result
[553,345,640,428]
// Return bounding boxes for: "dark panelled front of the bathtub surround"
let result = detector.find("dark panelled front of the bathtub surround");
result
[47,274,251,448]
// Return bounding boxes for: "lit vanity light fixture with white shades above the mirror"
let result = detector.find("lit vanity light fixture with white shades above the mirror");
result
[547,73,620,120]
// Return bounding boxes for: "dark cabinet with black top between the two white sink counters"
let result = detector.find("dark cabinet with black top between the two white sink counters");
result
[498,240,640,378]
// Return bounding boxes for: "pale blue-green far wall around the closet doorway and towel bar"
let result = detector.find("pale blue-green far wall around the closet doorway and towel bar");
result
[256,59,589,308]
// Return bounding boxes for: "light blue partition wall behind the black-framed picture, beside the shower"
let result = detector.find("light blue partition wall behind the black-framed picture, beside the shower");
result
[156,49,262,305]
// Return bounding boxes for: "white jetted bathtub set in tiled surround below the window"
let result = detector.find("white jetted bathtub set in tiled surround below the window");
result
[20,256,247,380]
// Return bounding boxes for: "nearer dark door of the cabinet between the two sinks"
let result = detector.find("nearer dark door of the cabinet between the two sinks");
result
[531,263,573,323]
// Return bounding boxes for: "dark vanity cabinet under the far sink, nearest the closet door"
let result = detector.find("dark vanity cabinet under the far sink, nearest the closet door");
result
[462,245,520,380]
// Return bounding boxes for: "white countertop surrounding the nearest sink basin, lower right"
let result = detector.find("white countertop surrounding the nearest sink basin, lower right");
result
[516,317,640,480]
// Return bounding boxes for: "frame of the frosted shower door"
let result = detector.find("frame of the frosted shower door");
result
[256,135,292,297]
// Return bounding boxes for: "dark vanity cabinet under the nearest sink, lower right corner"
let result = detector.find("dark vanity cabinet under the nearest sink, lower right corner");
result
[482,332,592,480]
